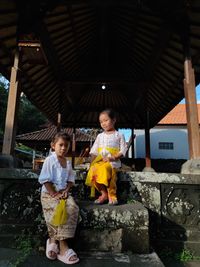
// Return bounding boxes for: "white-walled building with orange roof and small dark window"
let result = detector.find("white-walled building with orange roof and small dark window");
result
[132,104,200,159]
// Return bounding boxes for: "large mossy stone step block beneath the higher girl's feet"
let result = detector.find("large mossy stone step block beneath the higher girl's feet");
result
[74,201,149,253]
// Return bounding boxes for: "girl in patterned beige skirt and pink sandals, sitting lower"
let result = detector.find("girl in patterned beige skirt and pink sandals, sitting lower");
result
[39,132,79,264]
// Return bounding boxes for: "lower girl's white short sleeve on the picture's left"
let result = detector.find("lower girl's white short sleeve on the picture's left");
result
[39,157,53,184]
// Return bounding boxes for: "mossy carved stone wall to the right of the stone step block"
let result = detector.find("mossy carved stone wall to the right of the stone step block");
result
[120,172,200,255]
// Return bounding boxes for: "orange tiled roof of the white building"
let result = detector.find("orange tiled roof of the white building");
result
[158,104,200,125]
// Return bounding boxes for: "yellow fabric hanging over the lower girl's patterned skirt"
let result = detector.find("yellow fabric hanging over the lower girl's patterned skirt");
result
[51,199,67,226]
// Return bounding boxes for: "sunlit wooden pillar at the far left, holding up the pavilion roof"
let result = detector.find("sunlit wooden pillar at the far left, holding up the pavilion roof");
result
[2,51,20,155]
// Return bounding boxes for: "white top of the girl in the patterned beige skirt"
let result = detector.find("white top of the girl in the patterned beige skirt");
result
[39,152,75,192]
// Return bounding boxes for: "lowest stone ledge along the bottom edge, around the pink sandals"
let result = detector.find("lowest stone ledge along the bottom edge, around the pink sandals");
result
[0,248,164,267]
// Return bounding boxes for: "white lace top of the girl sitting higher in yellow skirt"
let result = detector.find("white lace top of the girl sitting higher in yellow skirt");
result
[90,131,127,168]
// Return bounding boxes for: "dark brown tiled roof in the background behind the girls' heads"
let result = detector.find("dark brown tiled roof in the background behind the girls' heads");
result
[16,126,95,142]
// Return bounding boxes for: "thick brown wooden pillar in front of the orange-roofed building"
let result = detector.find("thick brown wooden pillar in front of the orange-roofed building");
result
[184,58,200,159]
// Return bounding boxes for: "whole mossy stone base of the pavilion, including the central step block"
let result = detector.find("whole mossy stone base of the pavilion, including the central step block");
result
[0,169,200,254]
